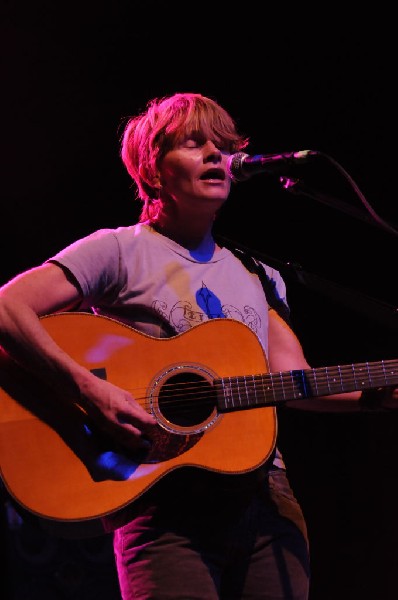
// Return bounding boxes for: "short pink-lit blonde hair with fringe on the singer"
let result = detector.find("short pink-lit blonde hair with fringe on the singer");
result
[120,93,249,222]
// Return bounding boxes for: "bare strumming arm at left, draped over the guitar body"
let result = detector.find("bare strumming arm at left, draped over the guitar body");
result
[0,263,155,448]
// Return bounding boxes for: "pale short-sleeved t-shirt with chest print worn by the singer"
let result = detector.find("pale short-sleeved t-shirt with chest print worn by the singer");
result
[50,224,286,467]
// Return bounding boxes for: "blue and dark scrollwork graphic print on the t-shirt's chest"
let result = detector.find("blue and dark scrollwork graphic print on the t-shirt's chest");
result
[152,282,261,333]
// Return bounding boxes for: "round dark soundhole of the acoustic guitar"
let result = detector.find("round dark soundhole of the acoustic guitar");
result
[159,372,216,427]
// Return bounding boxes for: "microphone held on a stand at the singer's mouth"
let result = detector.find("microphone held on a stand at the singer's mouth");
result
[227,150,319,181]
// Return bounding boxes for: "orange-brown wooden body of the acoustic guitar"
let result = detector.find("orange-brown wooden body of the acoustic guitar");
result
[0,313,277,522]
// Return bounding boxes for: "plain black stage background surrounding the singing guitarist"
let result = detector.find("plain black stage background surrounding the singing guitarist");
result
[0,1,398,600]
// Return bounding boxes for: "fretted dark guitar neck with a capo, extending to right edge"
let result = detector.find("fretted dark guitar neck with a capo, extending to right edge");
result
[218,360,398,412]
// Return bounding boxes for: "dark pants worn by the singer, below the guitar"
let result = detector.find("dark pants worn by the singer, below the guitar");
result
[114,469,309,600]
